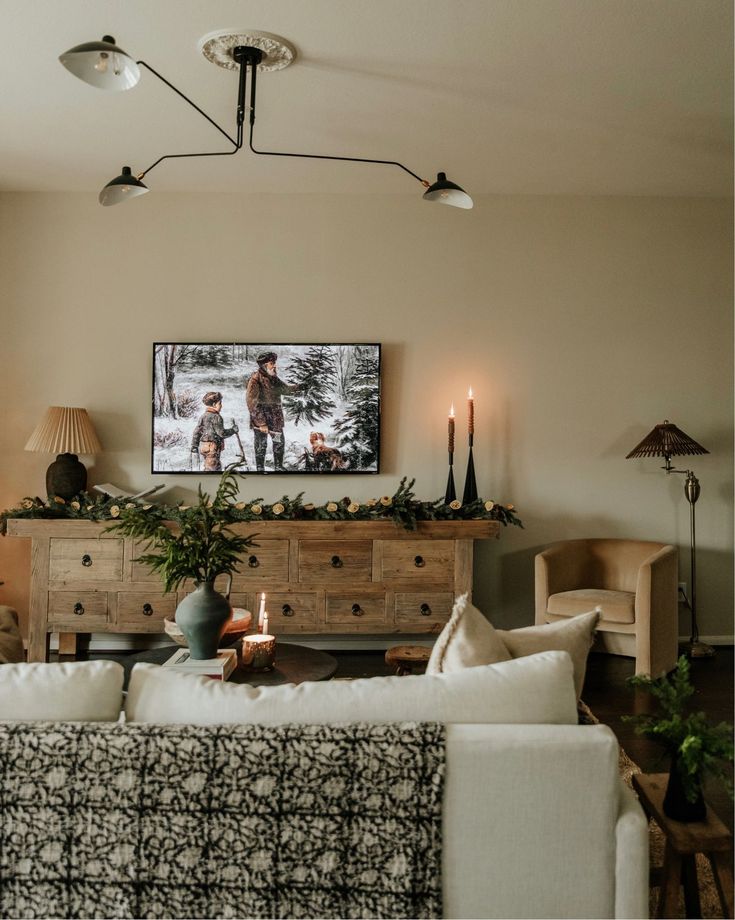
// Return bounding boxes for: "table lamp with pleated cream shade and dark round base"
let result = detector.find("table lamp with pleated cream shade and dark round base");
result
[25,406,102,500]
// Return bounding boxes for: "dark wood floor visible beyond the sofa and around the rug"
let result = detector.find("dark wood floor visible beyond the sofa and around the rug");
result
[331,646,735,830]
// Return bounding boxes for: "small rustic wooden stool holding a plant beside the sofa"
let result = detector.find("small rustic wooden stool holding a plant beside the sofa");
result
[632,773,733,917]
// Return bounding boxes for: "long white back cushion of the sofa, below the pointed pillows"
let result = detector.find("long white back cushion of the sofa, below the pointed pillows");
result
[125,652,577,725]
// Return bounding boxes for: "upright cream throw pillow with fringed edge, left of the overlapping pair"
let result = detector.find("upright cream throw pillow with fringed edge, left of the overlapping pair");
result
[426,594,513,674]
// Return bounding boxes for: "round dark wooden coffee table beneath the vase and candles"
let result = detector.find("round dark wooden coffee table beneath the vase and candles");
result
[115,642,337,690]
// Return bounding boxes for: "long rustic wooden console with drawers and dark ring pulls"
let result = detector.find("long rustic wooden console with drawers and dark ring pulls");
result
[8,518,500,661]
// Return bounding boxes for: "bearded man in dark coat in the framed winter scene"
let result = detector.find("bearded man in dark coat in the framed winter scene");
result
[245,351,301,473]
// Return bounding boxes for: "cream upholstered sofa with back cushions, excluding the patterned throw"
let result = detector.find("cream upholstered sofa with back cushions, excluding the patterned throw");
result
[0,652,648,918]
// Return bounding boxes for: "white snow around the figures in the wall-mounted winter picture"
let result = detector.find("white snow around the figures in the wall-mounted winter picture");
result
[153,348,376,473]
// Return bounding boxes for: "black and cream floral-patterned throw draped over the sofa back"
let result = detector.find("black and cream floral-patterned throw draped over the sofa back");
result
[0,723,444,918]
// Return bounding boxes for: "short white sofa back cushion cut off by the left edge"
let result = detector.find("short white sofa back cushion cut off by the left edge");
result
[0,661,125,722]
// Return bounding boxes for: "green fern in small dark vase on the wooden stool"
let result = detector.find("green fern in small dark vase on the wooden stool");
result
[624,656,733,821]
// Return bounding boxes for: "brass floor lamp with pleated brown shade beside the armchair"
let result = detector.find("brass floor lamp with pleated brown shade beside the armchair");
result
[625,419,715,658]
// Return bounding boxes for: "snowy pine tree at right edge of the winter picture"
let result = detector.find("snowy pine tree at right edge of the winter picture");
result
[334,352,380,469]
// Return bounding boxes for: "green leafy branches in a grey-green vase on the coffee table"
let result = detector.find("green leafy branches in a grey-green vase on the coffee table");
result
[114,470,254,659]
